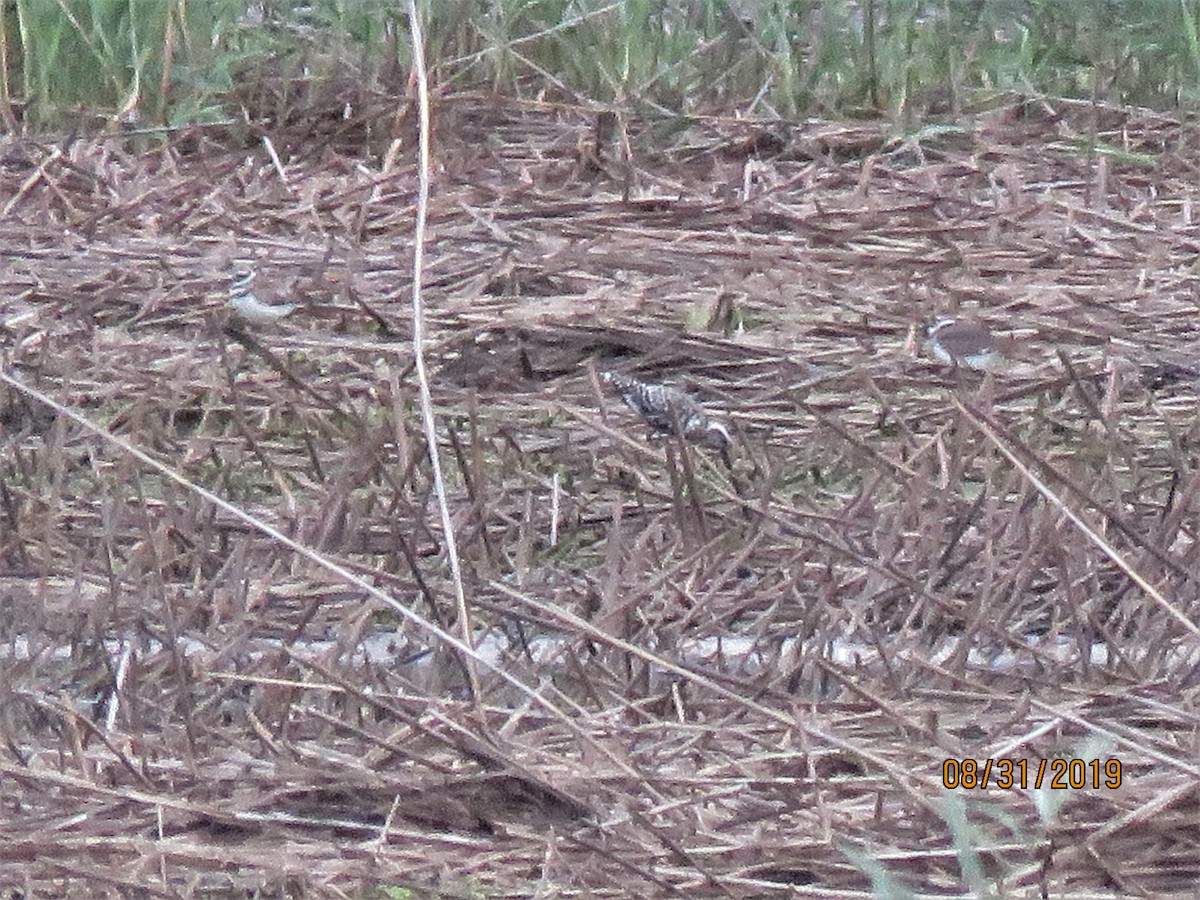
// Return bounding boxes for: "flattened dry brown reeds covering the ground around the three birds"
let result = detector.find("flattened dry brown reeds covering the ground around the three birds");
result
[0,95,1200,896]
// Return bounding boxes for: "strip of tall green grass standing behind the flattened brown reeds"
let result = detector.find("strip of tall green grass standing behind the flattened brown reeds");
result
[7,0,1200,128]
